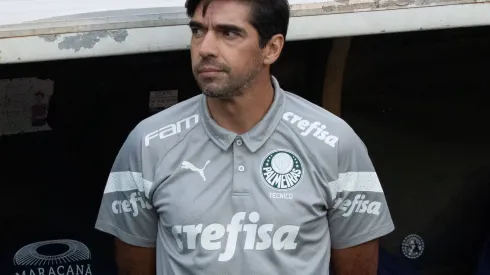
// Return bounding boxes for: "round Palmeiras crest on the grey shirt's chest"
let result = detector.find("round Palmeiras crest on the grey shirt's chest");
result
[260,149,303,191]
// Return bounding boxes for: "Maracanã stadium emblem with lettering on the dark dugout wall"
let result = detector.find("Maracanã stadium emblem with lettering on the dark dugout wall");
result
[14,240,93,275]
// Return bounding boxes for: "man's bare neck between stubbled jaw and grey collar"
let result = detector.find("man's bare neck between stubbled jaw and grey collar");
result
[207,73,274,134]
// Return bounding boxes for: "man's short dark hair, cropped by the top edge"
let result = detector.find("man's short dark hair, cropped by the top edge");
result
[185,0,289,48]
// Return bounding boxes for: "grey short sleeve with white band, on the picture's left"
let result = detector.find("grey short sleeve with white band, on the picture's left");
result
[95,130,158,247]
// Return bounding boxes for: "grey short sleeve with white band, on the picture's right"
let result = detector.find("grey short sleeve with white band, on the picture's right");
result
[328,129,394,249]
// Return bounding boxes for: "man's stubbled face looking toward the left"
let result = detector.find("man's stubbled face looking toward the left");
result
[190,0,264,98]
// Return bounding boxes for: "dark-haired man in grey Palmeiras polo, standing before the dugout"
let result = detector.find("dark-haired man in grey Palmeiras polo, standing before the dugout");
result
[96,0,394,275]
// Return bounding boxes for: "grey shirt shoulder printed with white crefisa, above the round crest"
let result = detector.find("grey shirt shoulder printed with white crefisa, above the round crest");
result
[283,92,359,151]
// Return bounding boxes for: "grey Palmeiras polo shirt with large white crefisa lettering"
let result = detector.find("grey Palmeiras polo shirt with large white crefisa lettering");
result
[96,78,394,275]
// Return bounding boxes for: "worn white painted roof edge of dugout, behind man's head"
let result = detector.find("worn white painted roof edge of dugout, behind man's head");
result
[0,4,490,64]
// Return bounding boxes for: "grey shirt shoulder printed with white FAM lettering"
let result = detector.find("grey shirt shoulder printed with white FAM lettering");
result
[128,95,201,150]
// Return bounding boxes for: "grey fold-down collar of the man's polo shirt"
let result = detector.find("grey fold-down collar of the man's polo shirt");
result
[200,76,285,152]
